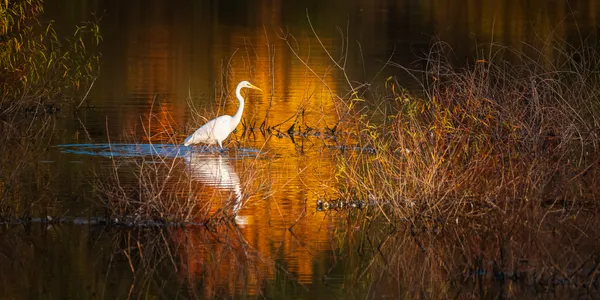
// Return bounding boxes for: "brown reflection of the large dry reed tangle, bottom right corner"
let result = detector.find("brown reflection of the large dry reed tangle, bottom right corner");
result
[342,206,600,298]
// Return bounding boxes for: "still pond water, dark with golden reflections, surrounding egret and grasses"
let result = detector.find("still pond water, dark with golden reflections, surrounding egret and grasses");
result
[0,0,600,299]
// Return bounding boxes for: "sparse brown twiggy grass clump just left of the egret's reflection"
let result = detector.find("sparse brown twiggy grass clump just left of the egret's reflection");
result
[93,155,203,225]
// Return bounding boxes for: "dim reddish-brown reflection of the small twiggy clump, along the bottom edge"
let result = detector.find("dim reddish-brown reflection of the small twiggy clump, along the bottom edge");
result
[94,226,276,298]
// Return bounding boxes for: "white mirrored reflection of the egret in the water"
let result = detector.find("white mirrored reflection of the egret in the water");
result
[185,152,246,225]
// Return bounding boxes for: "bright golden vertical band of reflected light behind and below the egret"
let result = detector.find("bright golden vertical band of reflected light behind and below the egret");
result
[166,13,338,290]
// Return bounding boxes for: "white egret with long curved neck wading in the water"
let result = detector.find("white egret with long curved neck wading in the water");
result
[183,80,262,148]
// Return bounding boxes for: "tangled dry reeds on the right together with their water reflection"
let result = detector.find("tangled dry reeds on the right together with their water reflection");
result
[310,37,600,299]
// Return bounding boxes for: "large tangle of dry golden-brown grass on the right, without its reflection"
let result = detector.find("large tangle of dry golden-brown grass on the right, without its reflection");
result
[332,42,600,217]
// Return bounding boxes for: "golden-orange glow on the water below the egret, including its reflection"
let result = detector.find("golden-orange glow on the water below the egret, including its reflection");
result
[176,144,335,293]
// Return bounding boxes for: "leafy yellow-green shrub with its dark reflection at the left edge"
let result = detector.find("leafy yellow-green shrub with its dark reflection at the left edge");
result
[0,0,101,221]
